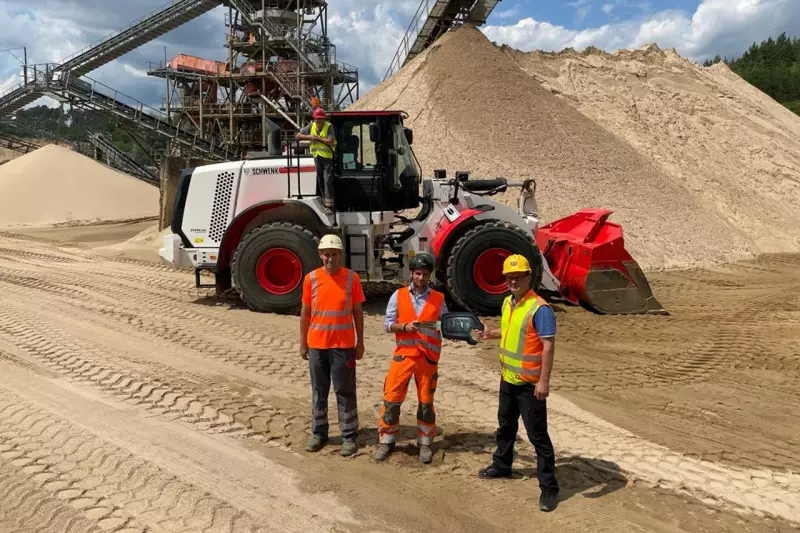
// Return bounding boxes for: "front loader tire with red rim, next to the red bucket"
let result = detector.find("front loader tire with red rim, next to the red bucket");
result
[445,221,542,316]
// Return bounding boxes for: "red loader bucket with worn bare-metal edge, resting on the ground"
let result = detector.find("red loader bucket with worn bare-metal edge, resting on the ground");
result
[536,209,669,314]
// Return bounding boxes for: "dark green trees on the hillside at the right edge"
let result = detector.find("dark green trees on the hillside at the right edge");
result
[703,32,800,115]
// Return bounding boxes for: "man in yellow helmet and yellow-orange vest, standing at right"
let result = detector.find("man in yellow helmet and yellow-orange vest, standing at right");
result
[478,255,559,511]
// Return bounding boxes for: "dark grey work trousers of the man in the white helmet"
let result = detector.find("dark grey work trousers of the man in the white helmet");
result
[308,348,358,440]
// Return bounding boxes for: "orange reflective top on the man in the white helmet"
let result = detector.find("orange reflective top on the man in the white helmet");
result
[306,267,360,350]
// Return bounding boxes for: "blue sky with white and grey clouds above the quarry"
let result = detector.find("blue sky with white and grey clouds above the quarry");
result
[0,0,800,106]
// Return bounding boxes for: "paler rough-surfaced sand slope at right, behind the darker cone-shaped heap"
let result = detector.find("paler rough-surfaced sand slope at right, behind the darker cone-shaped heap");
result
[504,45,800,258]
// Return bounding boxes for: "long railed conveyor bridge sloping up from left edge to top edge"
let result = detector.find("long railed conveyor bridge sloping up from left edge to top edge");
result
[0,0,222,115]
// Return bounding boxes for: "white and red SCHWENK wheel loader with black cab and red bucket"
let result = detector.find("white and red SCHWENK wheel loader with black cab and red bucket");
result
[159,111,665,316]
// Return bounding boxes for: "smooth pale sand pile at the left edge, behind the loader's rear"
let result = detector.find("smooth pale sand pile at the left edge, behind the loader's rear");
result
[0,145,159,227]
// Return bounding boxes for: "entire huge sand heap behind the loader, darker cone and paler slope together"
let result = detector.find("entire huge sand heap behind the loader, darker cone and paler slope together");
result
[353,27,800,269]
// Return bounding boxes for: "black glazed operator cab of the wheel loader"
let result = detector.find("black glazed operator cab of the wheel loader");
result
[328,111,422,212]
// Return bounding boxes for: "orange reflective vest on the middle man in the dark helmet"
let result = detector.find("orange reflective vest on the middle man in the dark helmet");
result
[394,287,444,362]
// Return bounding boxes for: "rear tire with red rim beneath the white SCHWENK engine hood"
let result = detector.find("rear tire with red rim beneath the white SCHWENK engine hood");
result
[231,222,322,315]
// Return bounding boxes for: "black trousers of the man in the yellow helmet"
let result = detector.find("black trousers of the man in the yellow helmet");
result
[492,379,558,491]
